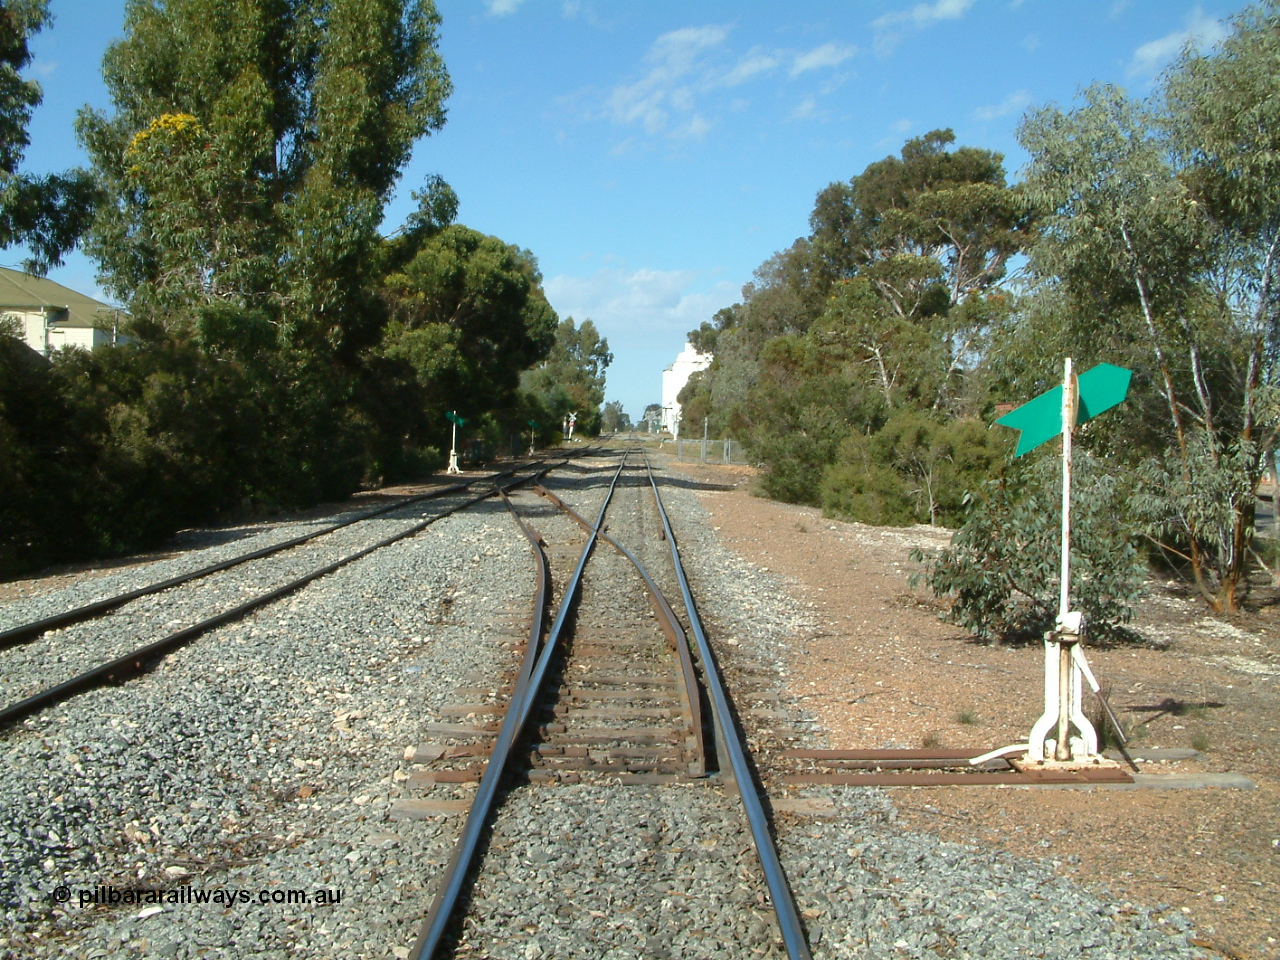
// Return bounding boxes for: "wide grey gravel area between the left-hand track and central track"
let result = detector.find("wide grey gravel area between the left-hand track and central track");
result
[0,491,530,959]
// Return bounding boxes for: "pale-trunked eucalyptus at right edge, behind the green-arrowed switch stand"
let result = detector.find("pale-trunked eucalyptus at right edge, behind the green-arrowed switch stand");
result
[1019,3,1280,612]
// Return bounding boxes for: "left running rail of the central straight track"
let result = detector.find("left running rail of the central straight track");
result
[410,456,626,960]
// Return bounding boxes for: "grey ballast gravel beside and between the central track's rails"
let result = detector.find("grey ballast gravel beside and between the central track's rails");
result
[0,461,1201,960]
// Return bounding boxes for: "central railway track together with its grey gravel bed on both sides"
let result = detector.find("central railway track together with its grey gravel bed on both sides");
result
[0,442,1190,960]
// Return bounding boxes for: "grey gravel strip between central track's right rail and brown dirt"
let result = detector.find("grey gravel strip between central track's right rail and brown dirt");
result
[640,461,1206,960]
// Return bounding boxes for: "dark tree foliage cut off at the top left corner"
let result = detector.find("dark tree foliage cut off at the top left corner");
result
[0,0,95,274]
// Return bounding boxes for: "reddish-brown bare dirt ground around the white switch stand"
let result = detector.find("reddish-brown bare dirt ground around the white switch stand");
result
[672,462,1280,960]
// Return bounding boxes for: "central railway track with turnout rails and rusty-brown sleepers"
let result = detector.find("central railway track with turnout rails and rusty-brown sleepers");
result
[399,457,810,960]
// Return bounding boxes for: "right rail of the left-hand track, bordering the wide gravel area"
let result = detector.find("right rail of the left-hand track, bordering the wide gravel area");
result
[0,467,553,726]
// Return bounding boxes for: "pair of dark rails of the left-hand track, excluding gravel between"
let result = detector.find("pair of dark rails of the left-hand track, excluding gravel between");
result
[0,461,563,726]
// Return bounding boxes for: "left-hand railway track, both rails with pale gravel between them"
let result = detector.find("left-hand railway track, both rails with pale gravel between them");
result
[0,461,570,726]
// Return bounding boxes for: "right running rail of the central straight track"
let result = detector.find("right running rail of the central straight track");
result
[645,457,812,960]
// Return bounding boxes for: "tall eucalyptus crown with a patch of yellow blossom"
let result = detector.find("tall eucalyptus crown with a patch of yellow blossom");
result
[78,0,449,351]
